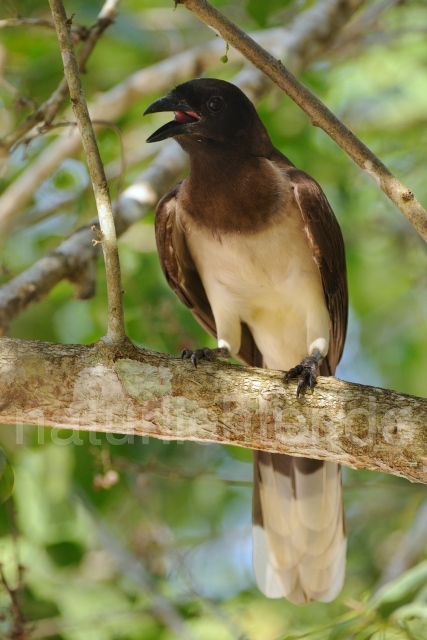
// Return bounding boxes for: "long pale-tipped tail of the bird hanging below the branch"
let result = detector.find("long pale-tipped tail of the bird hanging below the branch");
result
[253,451,347,604]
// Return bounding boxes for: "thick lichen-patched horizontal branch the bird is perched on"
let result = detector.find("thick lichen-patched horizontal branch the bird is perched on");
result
[0,338,427,483]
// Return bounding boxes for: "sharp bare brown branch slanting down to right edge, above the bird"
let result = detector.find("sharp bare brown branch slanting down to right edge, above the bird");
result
[176,0,427,242]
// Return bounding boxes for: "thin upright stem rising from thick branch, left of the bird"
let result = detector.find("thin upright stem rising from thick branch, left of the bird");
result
[49,0,126,343]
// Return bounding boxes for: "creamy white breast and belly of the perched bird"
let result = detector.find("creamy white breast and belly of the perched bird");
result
[180,205,329,369]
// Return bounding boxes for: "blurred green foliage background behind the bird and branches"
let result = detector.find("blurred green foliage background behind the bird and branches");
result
[0,0,427,640]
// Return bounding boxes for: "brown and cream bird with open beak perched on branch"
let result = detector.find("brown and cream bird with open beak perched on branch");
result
[144,78,348,604]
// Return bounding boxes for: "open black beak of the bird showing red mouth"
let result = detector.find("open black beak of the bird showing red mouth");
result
[144,92,200,142]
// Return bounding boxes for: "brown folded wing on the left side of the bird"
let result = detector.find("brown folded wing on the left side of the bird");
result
[155,181,262,367]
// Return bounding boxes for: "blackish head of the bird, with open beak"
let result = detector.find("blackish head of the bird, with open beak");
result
[144,78,269,148]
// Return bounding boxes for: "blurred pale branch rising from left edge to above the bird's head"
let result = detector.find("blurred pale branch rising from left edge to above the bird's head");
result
[0,0,364,235]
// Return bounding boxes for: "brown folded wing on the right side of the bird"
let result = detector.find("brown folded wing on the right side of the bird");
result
[271,151,348,375]
